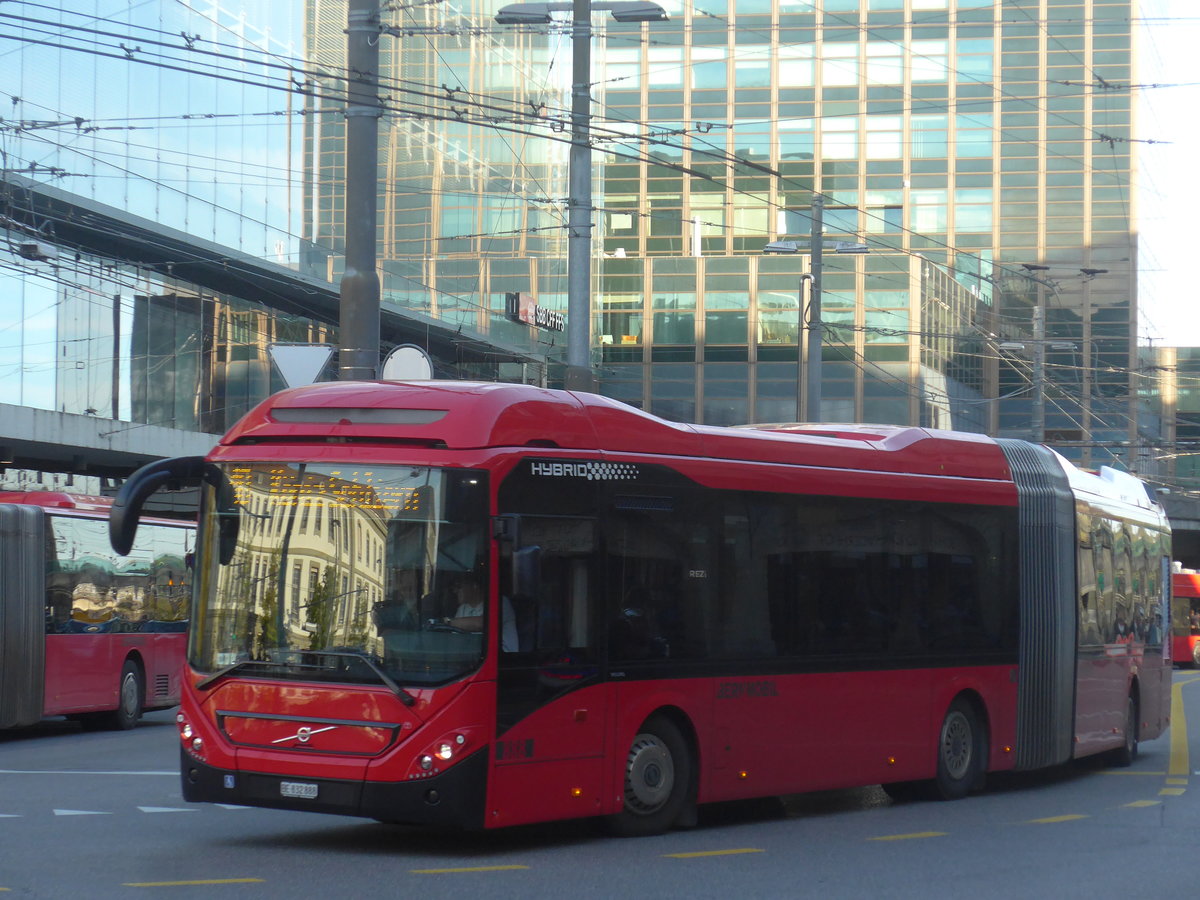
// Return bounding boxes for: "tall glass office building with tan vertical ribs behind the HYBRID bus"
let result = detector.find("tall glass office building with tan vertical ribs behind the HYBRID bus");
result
[300,0,1136,461]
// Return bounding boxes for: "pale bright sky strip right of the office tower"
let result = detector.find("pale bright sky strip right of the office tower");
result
[1133,0,1200,347]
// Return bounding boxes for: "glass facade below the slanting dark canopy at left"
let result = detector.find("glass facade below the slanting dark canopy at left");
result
[0,245,336,433]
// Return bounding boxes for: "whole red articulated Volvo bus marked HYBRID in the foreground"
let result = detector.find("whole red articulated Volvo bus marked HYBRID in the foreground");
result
[112,382,1171,834]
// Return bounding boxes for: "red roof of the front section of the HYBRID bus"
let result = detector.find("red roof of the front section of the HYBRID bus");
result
[221,382,1012,481]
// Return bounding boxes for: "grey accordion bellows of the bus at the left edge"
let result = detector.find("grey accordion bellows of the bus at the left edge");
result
[0,504,46,728]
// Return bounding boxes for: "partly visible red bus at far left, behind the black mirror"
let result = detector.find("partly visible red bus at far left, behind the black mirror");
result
[0,491,196,728]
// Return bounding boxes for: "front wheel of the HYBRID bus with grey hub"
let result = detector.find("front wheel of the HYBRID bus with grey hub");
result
[607,716,692,838]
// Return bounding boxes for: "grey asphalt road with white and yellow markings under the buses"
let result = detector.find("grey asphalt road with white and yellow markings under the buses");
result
[0,671,1200,900]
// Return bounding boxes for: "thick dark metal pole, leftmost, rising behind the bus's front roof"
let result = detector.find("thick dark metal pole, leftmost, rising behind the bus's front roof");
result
[337,0,382,382]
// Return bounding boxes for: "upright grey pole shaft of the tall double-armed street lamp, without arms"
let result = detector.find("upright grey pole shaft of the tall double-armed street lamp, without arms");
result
[566,0,593,391]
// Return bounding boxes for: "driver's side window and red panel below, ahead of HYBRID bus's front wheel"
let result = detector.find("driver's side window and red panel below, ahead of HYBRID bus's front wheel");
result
[487,516,610,827]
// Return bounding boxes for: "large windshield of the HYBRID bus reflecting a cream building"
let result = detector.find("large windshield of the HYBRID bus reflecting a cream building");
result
[188,462,487,691]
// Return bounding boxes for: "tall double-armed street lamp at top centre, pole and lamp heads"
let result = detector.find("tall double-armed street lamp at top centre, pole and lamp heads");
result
[496,0,668,391]
